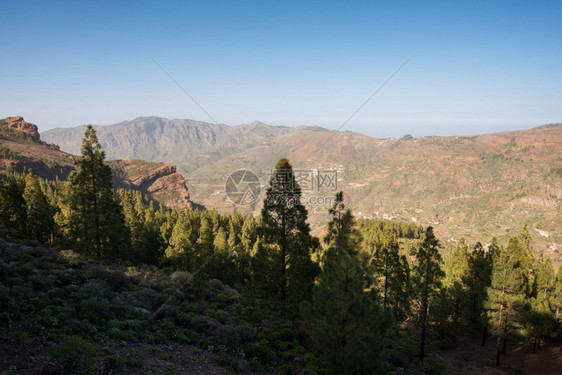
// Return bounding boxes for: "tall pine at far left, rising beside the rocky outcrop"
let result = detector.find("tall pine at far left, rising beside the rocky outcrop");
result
[59,125,129,257]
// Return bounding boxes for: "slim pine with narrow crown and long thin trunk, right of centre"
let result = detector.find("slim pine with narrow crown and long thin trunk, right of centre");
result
[413,227,444,361]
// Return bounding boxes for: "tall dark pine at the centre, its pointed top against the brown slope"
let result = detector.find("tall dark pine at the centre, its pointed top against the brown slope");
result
[261,158,318,312]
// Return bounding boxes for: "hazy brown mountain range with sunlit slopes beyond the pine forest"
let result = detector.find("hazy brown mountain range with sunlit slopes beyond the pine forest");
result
[15,117,562,258]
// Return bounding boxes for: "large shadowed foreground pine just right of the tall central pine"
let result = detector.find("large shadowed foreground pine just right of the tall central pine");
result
[312,192,385,374]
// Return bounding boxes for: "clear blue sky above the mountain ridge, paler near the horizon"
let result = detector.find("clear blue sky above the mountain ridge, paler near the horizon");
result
[0,0,562,137]
